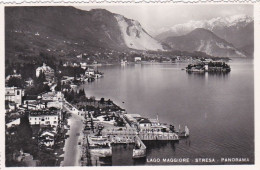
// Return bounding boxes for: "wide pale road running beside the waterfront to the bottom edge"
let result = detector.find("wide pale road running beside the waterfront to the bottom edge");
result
[61,114,83,166]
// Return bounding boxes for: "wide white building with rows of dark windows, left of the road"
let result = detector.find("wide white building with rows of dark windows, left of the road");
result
[29,110,59,127]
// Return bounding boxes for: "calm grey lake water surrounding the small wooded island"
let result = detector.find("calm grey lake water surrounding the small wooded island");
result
[85,59,254,165]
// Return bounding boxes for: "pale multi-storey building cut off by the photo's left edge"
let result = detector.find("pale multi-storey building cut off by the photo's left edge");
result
[5,87,24,106]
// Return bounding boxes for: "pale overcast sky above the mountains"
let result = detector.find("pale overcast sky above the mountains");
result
[76,4,253,35]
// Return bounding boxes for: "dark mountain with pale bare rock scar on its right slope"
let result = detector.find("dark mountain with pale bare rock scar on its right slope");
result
[5,7,164,59]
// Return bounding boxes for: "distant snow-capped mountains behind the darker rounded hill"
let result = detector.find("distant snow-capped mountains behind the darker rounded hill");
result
[156,15,254,56]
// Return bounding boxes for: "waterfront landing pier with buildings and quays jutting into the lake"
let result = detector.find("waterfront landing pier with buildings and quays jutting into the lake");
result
[63,101,189,166]
